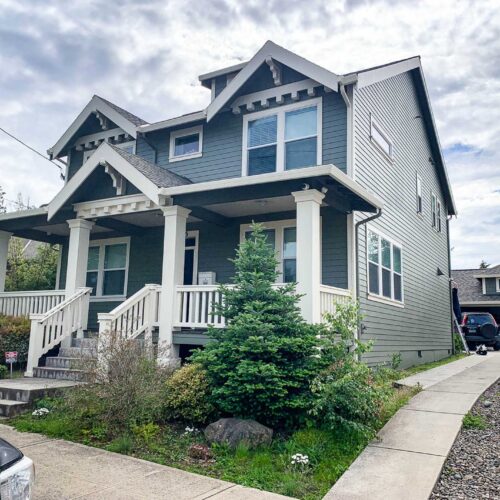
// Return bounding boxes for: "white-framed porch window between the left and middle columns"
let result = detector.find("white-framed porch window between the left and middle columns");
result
[87,238,130,298]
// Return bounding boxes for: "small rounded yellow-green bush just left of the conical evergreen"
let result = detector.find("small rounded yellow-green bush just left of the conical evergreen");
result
[165,363,214,424]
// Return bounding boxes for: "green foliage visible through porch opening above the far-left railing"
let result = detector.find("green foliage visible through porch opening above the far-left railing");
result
[5,238,59,292]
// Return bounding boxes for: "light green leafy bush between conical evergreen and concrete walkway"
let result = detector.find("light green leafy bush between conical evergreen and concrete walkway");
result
[310,303,386,434]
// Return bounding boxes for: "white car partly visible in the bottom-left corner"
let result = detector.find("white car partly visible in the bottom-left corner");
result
[0,438,35,500]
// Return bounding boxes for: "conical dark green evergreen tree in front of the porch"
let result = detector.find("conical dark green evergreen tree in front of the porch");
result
[192,224,318,427]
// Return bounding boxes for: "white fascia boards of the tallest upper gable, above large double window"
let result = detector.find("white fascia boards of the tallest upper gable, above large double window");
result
[207,41,340,122]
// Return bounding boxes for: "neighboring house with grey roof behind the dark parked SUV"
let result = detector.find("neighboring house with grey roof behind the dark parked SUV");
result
[451,264,500,324]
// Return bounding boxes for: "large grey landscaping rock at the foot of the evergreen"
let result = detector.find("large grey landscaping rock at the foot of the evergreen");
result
[205,418,273,448]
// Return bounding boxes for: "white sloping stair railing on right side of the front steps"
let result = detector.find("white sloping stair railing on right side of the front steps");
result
[97,285,161,340]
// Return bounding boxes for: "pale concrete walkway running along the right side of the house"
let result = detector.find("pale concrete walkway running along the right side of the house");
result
[324,352,500,500]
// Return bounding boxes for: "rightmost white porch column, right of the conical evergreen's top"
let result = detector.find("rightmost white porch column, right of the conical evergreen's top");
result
[292,189,325,323]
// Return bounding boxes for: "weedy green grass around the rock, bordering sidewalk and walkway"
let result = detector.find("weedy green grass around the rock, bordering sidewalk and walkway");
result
[9,376,418,500]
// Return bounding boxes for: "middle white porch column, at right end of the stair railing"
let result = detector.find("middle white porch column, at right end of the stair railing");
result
[158,205,190,365]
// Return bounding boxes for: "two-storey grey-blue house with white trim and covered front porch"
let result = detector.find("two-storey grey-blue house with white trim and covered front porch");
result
[0,42,455,374]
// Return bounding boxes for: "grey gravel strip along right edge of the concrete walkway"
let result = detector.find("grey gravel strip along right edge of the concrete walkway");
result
[430,381,500,500]
